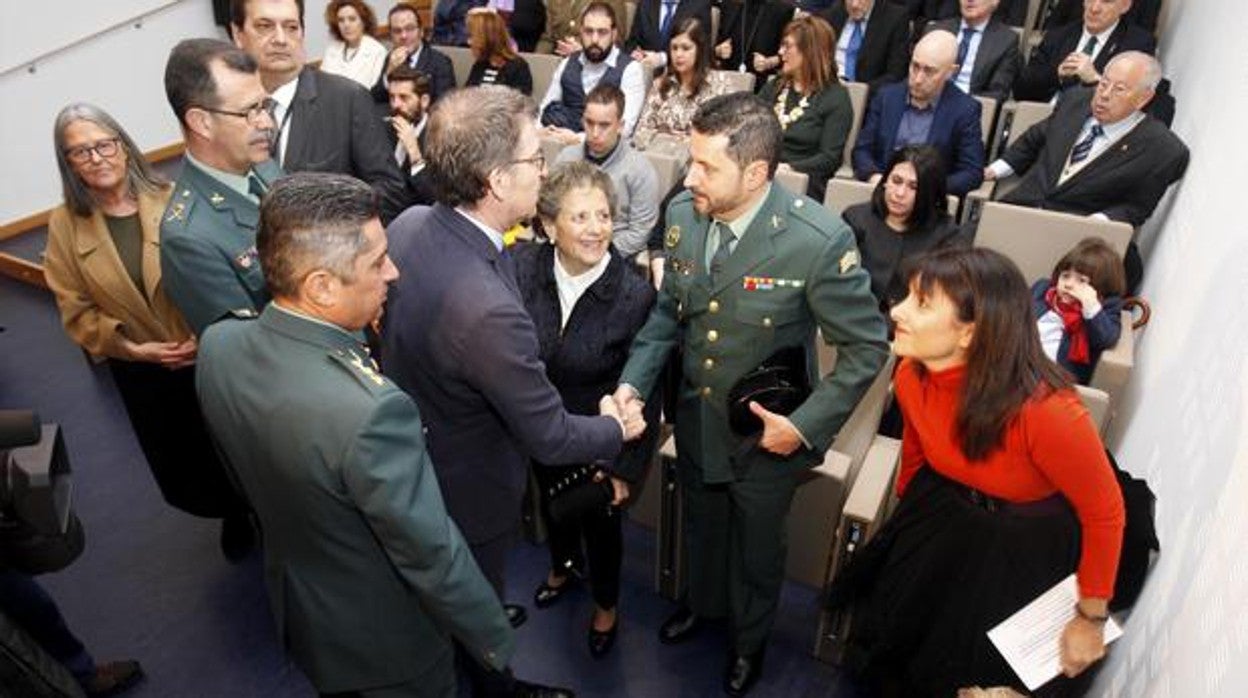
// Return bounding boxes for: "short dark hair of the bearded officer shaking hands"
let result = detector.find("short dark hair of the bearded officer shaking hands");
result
[691,92,784,179]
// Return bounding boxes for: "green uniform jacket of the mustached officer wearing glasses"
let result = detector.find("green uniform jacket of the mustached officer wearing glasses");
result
[160,157,282,335]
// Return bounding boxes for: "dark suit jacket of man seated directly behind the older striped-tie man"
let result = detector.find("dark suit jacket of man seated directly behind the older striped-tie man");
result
[1015,21,1157,102]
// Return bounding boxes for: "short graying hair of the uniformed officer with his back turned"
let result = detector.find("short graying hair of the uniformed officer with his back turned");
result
[256,172,378,298]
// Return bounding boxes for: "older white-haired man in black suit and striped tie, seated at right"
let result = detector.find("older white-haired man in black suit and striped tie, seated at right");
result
[983,51,1188,291]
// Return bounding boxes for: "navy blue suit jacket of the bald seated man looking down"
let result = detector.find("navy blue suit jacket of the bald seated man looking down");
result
[854,80,985,196]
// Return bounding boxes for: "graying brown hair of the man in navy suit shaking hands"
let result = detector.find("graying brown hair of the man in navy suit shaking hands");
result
[424,85,538,206]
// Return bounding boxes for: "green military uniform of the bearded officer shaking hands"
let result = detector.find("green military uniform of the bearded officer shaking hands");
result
[620,185,889,654]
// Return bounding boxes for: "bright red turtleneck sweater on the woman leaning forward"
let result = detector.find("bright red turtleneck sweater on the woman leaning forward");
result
[894,360,1124,599]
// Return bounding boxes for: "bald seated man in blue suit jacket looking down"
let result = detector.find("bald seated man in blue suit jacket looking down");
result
[854,31,983,196]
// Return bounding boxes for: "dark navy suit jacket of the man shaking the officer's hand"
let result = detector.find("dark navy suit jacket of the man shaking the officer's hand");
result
[382,204,622,544]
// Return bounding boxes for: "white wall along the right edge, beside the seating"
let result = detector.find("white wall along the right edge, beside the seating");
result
[1093,0,1248,697]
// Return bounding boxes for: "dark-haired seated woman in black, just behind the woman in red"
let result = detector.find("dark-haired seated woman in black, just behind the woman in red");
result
[841,145,971,312]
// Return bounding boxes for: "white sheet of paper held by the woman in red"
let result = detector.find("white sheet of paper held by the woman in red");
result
[988,574,1122,691]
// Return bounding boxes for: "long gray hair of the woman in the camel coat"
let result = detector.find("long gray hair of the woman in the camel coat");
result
[52,102,168,216]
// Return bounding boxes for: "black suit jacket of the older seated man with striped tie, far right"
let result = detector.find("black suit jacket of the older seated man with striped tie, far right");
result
[1002,87,1188,227]
